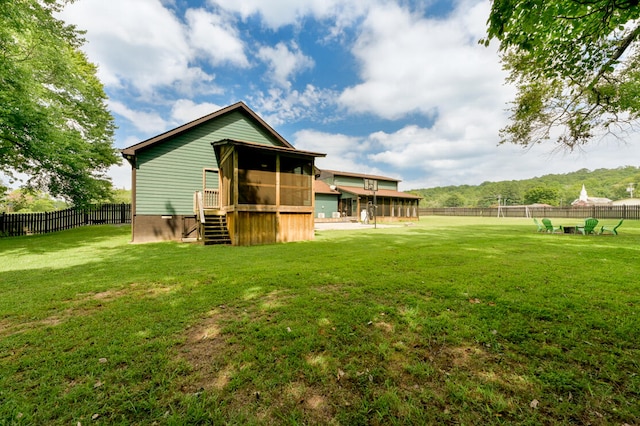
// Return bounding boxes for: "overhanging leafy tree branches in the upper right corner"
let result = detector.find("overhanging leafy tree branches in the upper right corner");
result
[481,0,640,150]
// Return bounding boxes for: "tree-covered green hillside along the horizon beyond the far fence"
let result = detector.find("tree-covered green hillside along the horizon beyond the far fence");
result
[407,166,640,207]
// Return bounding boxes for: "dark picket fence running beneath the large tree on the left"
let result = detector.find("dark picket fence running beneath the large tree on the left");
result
[0,204,131,237]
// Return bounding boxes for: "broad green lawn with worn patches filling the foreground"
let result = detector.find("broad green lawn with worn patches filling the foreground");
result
[0,217,640,425]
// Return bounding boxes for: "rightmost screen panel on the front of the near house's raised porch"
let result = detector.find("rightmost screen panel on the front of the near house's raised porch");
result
[280,156,313,206]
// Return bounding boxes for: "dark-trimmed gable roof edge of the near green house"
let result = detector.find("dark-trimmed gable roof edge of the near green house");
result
[120,102,295,158]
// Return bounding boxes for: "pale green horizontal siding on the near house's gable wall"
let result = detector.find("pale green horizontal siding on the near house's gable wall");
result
[136,111,281,215]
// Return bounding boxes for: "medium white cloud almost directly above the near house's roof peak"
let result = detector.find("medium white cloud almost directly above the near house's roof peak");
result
[185,9,249,68]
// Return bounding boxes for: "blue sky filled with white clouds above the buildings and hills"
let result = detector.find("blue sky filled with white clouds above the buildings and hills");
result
[61,0,640,190]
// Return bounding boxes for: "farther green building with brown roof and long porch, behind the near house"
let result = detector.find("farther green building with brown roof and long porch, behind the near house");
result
[316,170,422,220]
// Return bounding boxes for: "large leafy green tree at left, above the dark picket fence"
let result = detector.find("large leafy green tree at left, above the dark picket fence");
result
[0,0,120,205]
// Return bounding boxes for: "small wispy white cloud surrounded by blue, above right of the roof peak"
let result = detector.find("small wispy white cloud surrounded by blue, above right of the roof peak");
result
[257,42,314,88]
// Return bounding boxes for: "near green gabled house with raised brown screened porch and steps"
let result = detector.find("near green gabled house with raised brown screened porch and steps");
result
[121,102,324,245]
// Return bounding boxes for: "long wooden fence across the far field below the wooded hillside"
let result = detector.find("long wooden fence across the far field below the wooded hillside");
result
[419,206,640,220]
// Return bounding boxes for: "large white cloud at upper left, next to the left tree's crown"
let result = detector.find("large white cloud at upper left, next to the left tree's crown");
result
[62,0,213,95]
